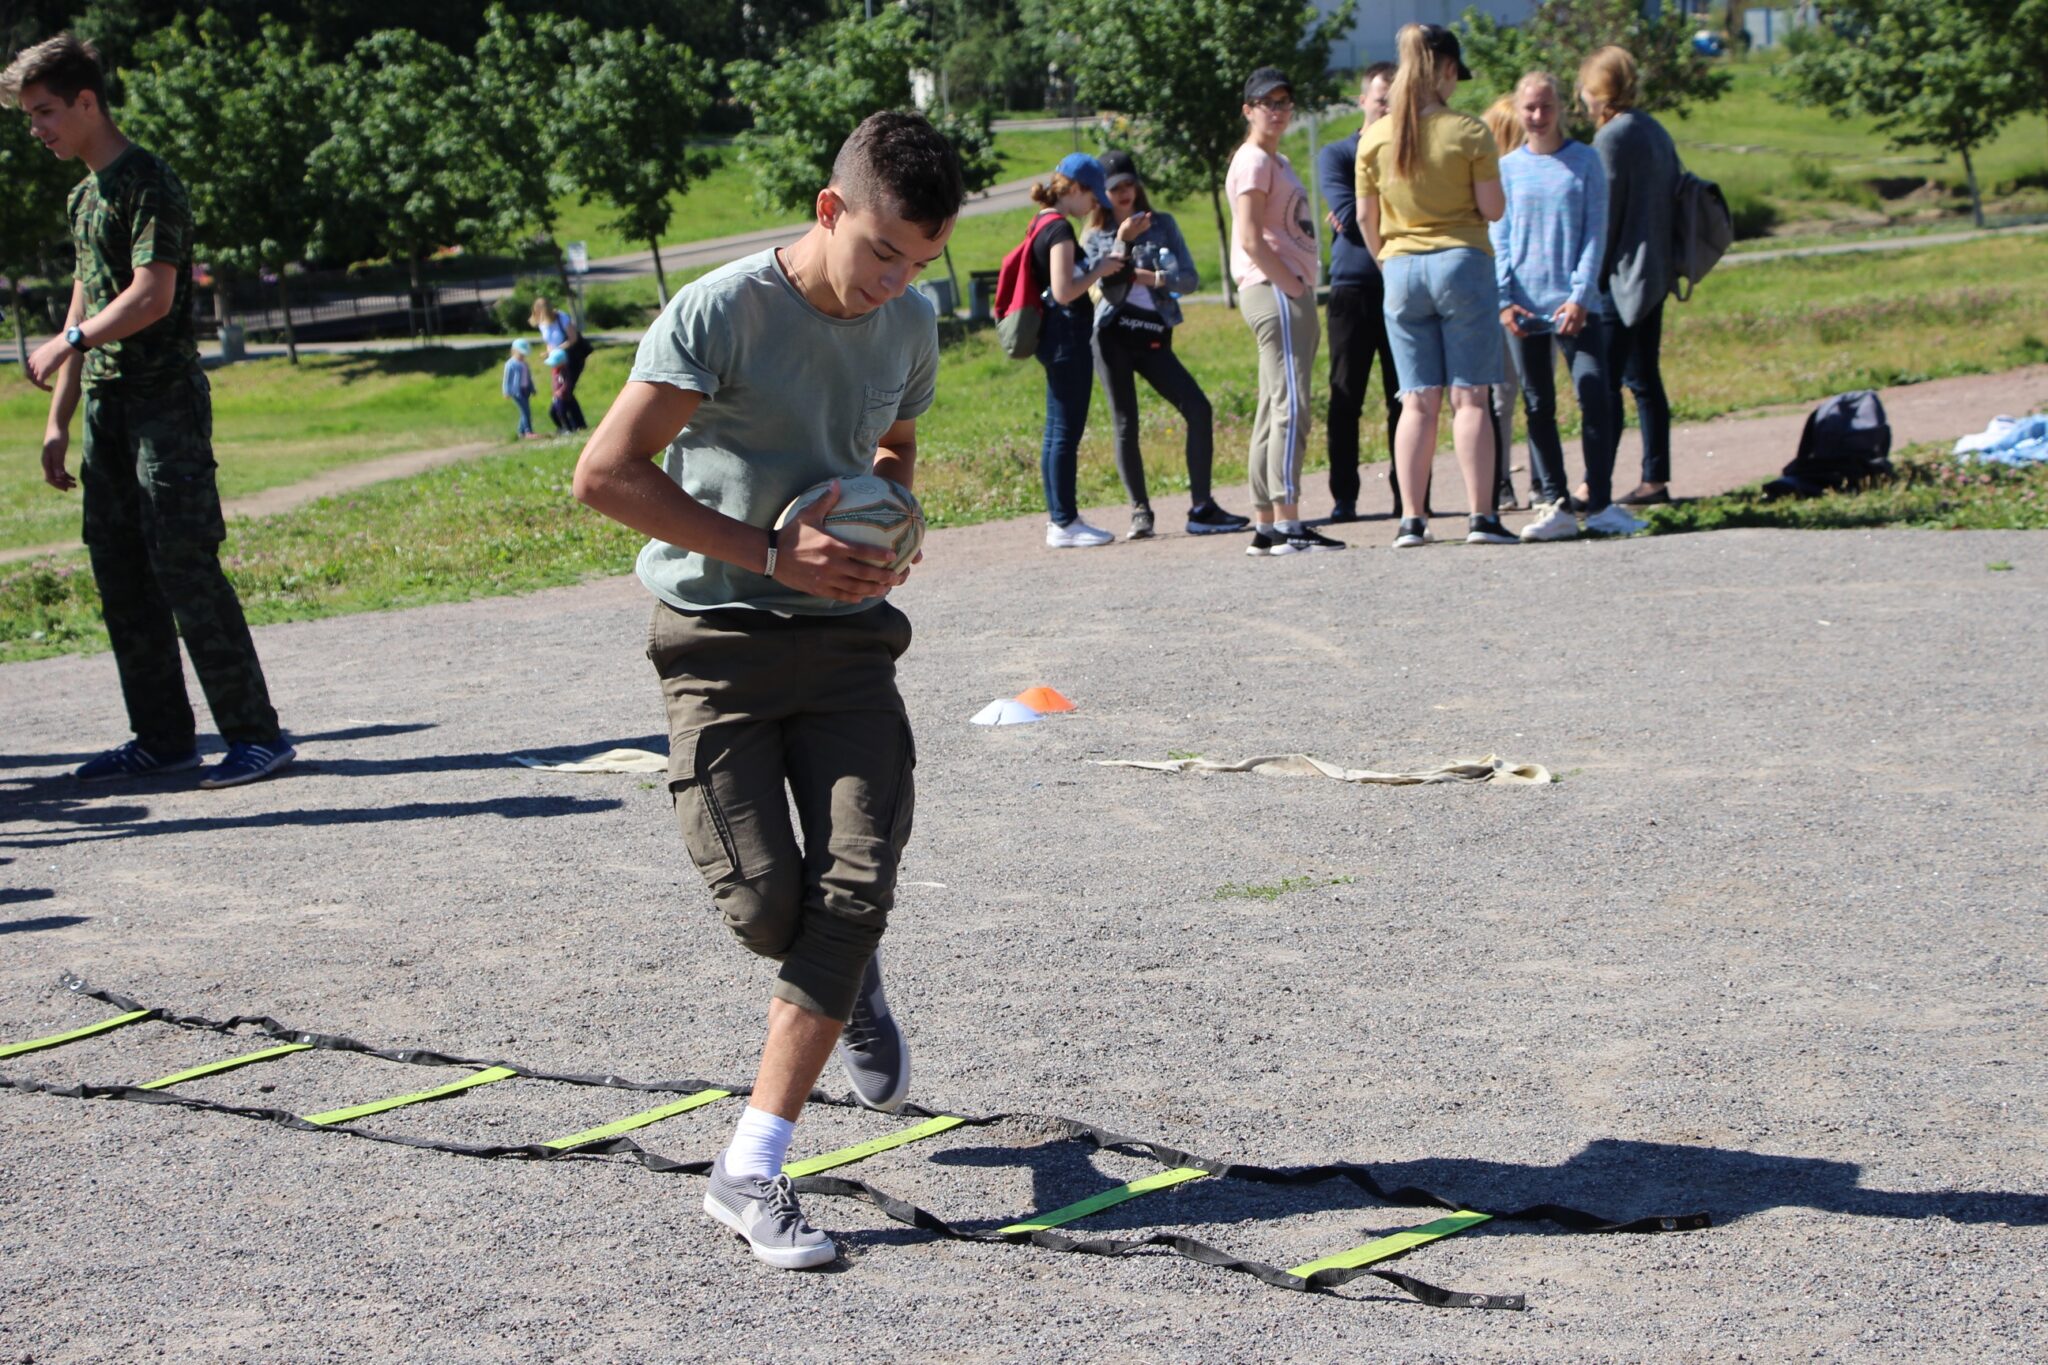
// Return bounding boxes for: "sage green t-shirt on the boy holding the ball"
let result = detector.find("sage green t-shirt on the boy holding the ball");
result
[631,250,938,616]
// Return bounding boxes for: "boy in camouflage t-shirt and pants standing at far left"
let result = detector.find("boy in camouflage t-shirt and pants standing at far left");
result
[0,35,295,786]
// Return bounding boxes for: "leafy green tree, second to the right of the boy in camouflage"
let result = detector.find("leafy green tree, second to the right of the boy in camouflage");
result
[307,29,496,327]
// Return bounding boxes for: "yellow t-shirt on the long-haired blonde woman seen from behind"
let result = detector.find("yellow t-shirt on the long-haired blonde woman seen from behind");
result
[1358,108,1501,260]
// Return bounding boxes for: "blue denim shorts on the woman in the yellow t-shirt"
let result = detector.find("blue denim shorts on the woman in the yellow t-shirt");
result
[1380,246,1505,397]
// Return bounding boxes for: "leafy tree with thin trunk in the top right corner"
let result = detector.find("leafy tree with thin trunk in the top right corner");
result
[1784,0,2038,227]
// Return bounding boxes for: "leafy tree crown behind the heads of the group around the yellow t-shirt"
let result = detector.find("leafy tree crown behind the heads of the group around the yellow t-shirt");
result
[1458,0,1735,131]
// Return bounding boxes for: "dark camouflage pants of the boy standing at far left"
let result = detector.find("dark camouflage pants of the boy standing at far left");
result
[80,372,279,753]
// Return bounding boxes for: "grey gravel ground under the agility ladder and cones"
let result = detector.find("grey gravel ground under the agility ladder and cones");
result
[0,516,2048,1361]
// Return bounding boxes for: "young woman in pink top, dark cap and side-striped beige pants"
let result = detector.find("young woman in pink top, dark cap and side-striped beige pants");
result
[1223,65,1343,555]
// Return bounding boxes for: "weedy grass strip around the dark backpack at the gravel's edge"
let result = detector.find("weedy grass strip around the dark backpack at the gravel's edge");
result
[1649,444,2048,536]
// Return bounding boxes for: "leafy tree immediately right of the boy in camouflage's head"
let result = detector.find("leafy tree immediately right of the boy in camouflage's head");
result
[121,10,334,364]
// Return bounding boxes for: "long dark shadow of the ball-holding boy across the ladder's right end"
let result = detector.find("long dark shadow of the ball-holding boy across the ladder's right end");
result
[932,1138,2048,1254]
